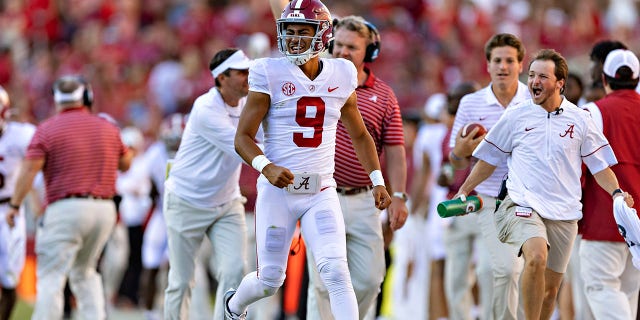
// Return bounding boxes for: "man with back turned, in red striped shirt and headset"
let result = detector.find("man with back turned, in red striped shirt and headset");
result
[7,76,132,319]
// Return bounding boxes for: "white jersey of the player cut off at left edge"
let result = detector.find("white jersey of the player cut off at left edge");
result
[0,121,36,199]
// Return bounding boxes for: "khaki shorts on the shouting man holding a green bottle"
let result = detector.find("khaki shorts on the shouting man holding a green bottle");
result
[495,196,578,273]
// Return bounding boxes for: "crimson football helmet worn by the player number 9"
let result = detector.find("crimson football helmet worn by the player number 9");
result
[276,0,333,66]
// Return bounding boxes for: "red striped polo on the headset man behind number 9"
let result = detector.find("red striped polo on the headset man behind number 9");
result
[333,68,404,187]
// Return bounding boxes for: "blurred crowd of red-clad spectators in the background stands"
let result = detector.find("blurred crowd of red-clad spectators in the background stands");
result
[0,0,640,131]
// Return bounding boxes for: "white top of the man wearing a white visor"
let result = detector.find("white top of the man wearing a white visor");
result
[165,88,246,208]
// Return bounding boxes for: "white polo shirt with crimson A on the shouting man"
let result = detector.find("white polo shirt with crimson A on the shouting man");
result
[473,99,617,220]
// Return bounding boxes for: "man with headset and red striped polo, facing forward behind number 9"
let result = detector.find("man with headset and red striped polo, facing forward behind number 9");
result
[307,16,408,320]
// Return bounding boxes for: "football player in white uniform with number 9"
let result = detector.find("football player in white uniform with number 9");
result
[224,0,391,319]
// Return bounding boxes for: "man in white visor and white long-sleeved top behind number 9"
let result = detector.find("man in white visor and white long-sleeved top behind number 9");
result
[163,49,251,319]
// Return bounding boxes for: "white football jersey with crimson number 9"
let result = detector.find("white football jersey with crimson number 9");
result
[249,57,358,186]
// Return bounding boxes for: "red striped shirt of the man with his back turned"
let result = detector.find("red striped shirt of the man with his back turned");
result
[26,107,127,204]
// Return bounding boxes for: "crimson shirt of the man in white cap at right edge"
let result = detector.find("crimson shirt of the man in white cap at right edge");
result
[580,90,640,242]
